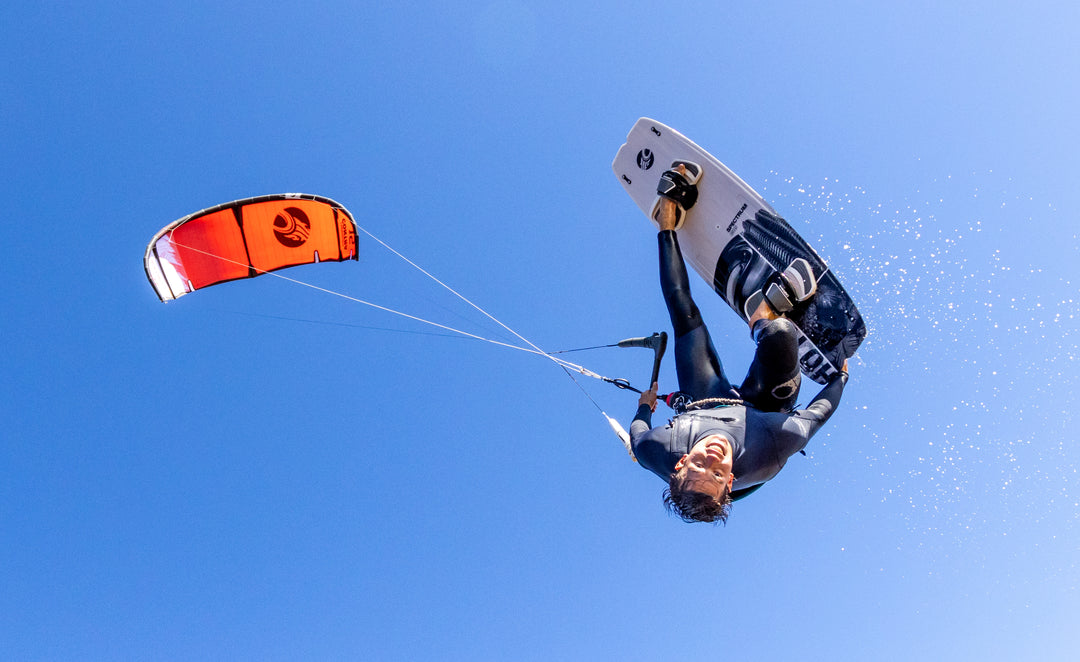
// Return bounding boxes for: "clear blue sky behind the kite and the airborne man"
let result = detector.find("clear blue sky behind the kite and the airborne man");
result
[0,1,1080,660]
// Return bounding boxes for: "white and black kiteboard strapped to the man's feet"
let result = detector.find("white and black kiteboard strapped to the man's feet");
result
[611,118,866,383]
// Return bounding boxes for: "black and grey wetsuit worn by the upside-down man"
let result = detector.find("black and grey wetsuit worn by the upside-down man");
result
[630,230,848,498]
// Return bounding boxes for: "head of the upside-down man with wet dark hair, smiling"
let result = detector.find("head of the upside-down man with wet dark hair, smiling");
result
[664,434,734,522]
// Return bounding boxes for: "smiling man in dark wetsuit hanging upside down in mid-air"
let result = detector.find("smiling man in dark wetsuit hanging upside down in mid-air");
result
[630,162,848,522]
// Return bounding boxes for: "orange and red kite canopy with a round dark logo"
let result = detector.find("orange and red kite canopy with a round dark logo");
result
[144,193,360,301]
